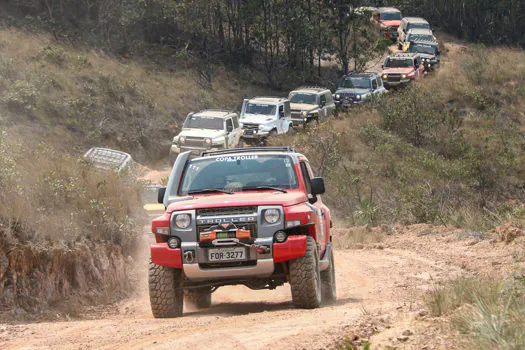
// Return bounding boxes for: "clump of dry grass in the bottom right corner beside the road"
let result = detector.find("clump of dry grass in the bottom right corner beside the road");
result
[425,276,525,349]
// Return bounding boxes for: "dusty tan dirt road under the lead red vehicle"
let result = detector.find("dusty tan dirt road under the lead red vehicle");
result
[0,225,512,350]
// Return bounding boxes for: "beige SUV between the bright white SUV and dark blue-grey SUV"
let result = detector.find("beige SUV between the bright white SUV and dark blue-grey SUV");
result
[288,87,335,126]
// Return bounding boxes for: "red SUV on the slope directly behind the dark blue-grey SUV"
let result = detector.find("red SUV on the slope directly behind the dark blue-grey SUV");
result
[381,53,425,89]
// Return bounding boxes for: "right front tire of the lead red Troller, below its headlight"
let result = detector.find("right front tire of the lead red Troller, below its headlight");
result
[289,236,322,309]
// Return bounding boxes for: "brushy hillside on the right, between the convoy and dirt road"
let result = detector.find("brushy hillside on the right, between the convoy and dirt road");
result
[277,46,525,235]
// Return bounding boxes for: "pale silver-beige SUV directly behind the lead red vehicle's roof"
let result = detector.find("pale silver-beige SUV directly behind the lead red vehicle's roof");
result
[170,109,242,163]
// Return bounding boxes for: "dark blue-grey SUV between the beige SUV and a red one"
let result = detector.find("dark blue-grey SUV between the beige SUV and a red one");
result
[334,73,386,109]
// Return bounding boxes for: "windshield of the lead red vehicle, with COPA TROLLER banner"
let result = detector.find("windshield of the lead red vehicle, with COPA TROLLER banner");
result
[180,154,298,195]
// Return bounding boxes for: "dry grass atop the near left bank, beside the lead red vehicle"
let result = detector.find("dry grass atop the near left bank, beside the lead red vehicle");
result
[0,133,142,252]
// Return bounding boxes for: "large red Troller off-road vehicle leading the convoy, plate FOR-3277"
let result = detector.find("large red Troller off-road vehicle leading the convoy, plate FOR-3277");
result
[149,147,336,318]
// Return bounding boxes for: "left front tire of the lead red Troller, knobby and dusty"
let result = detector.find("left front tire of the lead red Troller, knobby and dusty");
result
[148,260,184,318]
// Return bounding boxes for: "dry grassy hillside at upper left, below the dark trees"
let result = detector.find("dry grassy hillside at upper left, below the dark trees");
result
[0,27,271,162]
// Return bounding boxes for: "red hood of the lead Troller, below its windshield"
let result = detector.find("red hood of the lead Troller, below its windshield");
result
[167,190,308,213]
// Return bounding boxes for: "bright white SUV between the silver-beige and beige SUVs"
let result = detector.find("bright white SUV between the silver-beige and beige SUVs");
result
[241,97,293,143]
